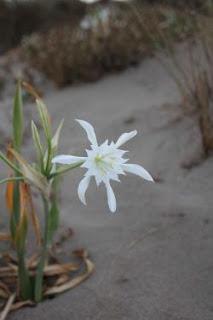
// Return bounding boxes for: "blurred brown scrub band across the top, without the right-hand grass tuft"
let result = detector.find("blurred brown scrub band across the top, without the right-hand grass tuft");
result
[0,0,212,92]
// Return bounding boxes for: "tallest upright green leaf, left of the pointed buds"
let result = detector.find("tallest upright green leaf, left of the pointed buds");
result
[12,81,24,151]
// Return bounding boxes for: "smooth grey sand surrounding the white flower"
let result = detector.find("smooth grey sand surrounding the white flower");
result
[1,51,213,320]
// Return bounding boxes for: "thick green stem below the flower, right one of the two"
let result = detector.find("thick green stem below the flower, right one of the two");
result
[34,197,50,303]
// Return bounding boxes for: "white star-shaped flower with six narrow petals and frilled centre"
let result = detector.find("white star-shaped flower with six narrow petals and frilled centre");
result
[52,120,153,212]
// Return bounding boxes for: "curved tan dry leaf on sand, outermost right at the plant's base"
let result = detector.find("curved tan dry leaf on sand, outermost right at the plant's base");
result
[44,253,95,296]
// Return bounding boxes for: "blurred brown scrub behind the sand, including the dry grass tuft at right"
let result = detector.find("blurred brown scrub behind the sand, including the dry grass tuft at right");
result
[0,0,213,154]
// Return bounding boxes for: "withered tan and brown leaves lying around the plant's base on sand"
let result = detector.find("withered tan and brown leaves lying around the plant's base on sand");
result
[0,249,94,320]
